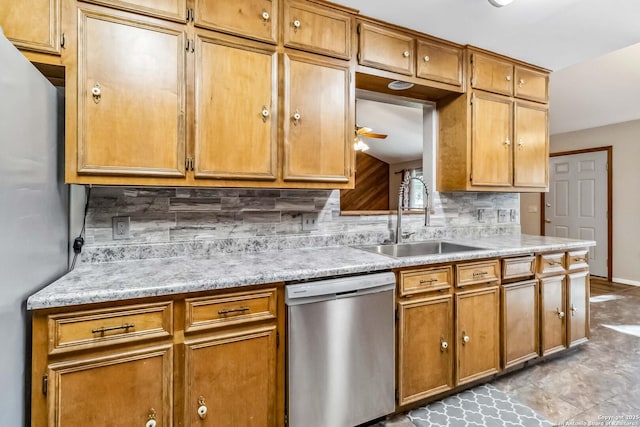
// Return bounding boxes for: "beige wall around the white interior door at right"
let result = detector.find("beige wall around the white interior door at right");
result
[520,120,640,285]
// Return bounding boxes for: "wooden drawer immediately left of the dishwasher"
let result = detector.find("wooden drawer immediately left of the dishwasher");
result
[185,288,276,332]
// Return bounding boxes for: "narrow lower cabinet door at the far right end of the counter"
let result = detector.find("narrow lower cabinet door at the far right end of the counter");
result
[567,271,589,346]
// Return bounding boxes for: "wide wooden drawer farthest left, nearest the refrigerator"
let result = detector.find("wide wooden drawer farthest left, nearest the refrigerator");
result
[48,302,173,354]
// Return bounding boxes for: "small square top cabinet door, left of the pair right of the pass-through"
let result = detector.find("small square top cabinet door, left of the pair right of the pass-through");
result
[471,53,513,95]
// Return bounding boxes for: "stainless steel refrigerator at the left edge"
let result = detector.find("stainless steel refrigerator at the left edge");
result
[0,28,69,427]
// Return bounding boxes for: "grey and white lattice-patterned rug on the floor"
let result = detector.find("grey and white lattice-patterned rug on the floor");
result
[407,384,553,427]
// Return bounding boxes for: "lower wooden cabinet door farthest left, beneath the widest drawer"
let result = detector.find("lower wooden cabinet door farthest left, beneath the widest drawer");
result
[47,346,173,427]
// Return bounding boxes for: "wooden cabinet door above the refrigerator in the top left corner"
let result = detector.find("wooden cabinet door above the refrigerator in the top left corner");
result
[0,0,60,53]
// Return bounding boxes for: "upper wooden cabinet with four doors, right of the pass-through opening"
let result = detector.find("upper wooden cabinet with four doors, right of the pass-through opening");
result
[436,48,549,192]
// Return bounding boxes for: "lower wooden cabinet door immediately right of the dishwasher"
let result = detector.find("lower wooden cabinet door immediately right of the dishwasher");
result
[398,295,454,405]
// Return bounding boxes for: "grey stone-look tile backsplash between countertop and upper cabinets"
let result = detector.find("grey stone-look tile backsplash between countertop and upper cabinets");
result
[77,187,520,262]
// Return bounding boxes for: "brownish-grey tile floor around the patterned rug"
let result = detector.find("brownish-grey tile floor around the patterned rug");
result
[380,278,640,427]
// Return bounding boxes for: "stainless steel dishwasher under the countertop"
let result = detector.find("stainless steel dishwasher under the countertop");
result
[286,272,395,427]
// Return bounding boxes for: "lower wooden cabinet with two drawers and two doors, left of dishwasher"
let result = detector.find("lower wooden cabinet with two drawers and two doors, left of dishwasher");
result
[31,285,284,427]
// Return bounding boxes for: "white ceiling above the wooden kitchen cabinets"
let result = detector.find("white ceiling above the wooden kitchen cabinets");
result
[336,0,640,134]
